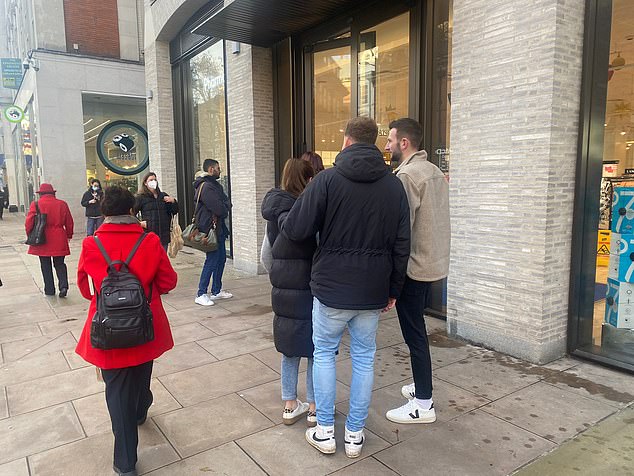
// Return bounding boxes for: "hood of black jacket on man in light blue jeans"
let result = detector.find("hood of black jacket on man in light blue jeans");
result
[335,143,390,182]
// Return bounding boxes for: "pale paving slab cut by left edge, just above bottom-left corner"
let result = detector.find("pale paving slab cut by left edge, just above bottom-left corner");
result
[0,403,84,463]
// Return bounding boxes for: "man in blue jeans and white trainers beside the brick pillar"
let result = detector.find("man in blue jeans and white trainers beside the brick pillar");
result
[194,159,233,306]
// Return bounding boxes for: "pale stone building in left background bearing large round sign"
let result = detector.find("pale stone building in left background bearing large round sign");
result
[2,0,148,226]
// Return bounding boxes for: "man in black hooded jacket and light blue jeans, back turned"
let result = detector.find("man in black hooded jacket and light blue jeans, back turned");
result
[282,117,410,458]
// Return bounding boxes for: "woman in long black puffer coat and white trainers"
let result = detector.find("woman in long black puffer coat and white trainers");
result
[262,159,317,426]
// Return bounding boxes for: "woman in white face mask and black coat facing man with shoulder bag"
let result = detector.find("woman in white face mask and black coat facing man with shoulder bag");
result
[134,172,178,251]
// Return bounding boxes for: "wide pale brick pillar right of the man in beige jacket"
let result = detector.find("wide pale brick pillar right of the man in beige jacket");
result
[447,0,585,362]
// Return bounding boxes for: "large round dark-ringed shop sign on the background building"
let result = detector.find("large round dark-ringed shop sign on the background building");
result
[97,121,150,175]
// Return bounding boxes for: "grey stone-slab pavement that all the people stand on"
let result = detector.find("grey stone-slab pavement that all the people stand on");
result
[0,214,634,476]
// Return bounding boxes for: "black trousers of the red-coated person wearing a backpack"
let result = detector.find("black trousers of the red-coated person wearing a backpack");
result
[101,360,154,473]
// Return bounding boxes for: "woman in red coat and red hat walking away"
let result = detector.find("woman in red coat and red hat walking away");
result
[25,183,74,297]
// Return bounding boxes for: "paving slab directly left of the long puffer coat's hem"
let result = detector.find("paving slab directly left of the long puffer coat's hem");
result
[198,324,275,360]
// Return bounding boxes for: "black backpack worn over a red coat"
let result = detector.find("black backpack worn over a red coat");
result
[90,233,154,350]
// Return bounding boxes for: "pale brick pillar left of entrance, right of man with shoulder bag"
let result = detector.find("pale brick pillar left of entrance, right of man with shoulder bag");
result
[226,45,275,273]
